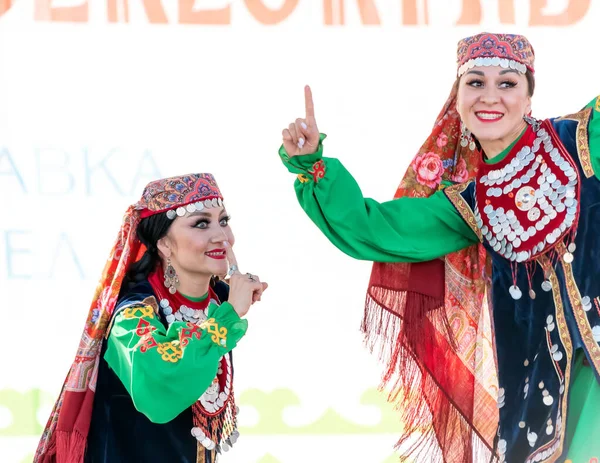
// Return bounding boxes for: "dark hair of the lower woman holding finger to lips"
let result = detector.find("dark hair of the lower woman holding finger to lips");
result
[122,212,173,292]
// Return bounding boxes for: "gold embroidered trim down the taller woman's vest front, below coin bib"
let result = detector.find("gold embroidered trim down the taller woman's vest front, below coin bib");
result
[527,256,573,463]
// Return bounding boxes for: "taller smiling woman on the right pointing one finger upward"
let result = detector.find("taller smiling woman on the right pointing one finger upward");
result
[279,33,600,463]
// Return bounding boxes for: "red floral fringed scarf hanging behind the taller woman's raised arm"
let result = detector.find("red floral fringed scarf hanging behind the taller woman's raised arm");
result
[362,89,498,463]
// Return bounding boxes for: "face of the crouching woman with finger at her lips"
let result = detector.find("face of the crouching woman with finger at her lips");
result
[158,207,235,280]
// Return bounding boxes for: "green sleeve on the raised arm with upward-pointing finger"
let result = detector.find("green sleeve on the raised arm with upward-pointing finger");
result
[279,135,478,262]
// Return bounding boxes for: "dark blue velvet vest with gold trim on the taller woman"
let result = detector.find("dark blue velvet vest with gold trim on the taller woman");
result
[446,109,600,462]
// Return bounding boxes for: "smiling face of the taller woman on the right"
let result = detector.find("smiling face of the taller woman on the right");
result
[456,66,531,151]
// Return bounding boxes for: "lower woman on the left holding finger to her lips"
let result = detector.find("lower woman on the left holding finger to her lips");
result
[35,174,267,463]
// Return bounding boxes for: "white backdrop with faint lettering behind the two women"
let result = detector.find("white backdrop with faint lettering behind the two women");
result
[0,0,600,463]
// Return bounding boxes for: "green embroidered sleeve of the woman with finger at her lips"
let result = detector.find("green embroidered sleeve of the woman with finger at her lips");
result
[104,302,248,423]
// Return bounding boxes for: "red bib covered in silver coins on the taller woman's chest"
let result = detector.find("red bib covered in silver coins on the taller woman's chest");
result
[476,121,579,266]
